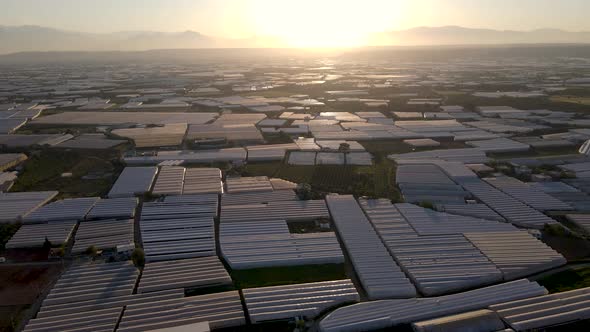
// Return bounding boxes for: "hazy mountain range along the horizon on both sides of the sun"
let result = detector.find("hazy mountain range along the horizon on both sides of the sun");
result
[0,26,590,54]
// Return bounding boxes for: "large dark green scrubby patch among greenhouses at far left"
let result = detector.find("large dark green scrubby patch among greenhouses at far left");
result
[11,149,123,198]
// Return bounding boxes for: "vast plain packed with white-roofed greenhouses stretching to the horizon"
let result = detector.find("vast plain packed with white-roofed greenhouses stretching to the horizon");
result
[0,41,590,332]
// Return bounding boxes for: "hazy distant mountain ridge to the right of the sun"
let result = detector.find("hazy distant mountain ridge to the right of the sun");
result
[370,26,590,45]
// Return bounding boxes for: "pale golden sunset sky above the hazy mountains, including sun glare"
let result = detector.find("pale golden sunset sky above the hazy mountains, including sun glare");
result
[0,0,590,46]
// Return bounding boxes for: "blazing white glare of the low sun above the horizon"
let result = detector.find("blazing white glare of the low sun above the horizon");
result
[250,0,398,48]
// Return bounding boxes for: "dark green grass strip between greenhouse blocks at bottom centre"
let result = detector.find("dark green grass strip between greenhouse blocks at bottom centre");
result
[230,264,348,289]
